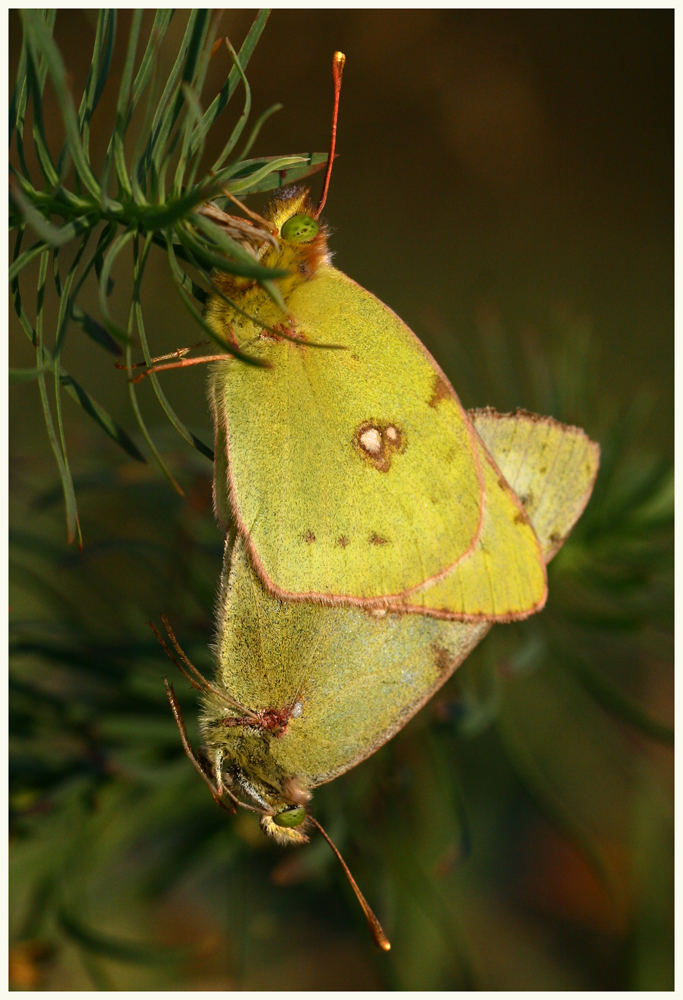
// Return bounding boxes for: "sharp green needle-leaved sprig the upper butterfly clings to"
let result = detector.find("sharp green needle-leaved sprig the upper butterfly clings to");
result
[9,9,326,538]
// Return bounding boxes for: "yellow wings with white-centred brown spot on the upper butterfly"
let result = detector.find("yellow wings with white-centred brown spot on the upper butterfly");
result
[210,263,546,620]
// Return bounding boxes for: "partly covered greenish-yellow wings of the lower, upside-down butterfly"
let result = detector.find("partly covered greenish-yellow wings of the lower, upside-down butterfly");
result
[213,410,599,787]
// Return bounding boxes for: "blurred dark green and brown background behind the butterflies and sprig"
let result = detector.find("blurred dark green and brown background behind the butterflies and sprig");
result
[10,10,673,990]
